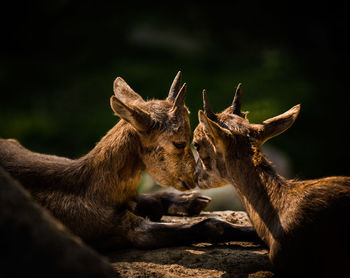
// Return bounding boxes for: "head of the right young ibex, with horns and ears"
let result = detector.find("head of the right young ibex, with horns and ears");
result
[193,84,300,188]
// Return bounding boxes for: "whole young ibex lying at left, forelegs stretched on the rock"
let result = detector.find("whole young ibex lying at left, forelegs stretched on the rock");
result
[0,72,242,251]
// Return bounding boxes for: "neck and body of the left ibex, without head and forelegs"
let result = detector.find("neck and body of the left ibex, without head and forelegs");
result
[0,121,145,240]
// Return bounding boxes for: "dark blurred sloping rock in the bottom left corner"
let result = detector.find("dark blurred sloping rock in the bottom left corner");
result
[0,167,118,278]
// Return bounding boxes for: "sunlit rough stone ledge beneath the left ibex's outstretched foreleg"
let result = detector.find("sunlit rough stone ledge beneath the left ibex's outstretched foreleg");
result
[108,211,274,278]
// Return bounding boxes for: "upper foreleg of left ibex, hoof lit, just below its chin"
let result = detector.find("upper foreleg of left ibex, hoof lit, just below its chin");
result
[135,191,211,221]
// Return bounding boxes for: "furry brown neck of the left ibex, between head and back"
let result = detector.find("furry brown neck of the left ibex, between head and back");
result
[77,120,145,206]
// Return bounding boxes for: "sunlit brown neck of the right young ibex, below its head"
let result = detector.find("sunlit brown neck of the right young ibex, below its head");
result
[229,153,287,246]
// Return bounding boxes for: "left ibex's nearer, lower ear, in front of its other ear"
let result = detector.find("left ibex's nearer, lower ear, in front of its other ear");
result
[110,96,152,132]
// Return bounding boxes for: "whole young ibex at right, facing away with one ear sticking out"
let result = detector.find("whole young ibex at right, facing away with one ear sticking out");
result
[193,85,350,277]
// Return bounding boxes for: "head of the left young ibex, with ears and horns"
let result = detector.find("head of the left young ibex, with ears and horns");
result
[111,72,195,190]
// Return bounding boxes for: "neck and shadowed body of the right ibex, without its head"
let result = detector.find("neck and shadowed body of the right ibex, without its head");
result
[228,155,350,277]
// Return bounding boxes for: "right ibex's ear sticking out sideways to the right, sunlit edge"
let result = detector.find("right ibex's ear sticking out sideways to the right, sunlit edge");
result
[260,104,300,142]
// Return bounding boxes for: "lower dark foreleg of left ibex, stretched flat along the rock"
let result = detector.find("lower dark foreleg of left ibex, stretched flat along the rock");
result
[89,210,259,251]
